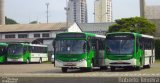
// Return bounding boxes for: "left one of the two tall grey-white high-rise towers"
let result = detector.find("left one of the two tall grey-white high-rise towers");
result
[65,0,87,24]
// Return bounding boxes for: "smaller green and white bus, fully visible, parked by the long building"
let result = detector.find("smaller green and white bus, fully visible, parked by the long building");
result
[7,43,48,63]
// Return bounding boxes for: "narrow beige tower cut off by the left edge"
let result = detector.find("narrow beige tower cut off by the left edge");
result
[0,0,5,25]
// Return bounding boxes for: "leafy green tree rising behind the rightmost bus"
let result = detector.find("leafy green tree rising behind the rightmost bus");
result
[109,17,156,35]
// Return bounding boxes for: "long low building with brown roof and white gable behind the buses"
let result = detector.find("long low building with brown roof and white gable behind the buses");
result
[0,23,82,48]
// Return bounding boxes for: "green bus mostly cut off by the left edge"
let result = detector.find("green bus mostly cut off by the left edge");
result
[0,43,8,63]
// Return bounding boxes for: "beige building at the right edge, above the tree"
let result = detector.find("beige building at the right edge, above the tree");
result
[145,6,160,19]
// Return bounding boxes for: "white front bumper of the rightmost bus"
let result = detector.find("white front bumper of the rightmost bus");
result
[106,59,136,67]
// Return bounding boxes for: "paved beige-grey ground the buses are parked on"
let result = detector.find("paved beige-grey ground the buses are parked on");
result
[0,61,160,76]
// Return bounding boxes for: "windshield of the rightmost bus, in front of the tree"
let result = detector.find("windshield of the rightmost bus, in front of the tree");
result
[106,39,134,55]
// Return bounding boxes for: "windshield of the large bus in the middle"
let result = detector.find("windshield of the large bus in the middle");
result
[55,40,86,54]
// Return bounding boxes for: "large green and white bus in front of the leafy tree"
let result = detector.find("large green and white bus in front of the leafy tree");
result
[105,32,155,71]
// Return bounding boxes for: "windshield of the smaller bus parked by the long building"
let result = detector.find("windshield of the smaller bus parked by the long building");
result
[8,44,23,55]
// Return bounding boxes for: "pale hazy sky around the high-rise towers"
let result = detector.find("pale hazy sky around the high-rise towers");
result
[4,0,160,24]
